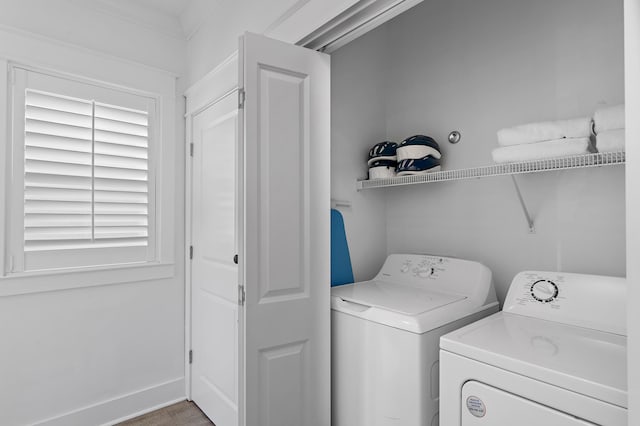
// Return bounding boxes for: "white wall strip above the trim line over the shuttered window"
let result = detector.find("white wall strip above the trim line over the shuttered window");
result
[0,0,186,75]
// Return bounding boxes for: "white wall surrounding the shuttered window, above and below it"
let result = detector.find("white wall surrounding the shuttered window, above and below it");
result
[0,0,185,425]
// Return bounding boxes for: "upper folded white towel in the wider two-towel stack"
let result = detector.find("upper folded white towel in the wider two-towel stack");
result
[498,117,591,146]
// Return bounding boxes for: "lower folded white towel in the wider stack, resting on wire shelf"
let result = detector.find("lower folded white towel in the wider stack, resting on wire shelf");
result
[491,138,593,163]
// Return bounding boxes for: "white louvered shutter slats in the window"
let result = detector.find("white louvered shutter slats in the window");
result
[24,89,149,252]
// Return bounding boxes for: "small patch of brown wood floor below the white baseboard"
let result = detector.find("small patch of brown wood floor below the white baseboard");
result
[118,401,215,426]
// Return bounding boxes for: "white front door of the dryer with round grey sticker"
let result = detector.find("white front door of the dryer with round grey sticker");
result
[461,381,595,426]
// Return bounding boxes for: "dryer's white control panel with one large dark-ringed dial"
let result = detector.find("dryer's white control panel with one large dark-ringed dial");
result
[503,271,626,334]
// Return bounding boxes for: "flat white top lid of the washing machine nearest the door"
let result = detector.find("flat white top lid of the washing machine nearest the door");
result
[331,281,466,316]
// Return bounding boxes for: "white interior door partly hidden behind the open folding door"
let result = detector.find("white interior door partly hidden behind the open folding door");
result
[191,92,239,426]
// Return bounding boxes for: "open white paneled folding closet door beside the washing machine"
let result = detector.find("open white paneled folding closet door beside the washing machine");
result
[240,34,330,426]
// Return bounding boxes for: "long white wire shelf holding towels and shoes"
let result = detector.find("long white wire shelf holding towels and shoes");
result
[357,151,625,191]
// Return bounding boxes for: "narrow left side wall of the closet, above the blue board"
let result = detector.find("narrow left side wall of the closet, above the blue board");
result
[331,27,388,281]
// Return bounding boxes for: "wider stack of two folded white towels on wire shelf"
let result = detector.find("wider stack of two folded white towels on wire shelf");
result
[491,117,594,163]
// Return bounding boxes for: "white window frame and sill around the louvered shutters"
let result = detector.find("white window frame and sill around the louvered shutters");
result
[0,61,168,282]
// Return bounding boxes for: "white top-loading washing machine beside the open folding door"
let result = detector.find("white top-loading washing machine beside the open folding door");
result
[331,254,498,426]
